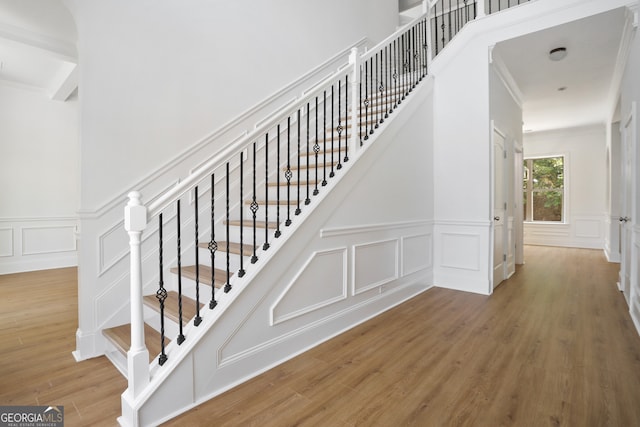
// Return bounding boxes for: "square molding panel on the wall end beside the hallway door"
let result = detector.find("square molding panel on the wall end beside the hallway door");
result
[441,233,480,271]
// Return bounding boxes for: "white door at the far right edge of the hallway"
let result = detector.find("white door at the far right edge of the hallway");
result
[618,104,635,304]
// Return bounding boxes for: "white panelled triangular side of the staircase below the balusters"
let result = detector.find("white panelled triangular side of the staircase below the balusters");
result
[119,78,433,425]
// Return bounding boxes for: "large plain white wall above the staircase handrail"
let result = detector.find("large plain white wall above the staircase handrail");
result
[66,0,398,212]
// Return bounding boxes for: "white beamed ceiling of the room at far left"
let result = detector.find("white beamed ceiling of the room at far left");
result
[0,0,78,101]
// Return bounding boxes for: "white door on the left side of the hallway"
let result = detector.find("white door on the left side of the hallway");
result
[493,129,507,289]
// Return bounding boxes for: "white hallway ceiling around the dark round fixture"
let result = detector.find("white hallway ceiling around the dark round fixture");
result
[494,8,625,132]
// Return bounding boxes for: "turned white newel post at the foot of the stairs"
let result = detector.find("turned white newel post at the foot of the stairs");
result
[124,191,149,398]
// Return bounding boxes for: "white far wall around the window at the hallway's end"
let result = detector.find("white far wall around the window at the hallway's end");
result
[524,124,607,249]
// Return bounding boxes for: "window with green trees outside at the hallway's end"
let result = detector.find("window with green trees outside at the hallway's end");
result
[523,156,565,222]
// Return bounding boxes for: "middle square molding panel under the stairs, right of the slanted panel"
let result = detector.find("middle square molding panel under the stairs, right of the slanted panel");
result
[353,239,399,295]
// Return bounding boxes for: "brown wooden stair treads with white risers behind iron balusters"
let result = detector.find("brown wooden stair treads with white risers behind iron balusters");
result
[102,75,424,377]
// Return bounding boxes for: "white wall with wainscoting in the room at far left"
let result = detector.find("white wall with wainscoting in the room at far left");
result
[0,85,80,274]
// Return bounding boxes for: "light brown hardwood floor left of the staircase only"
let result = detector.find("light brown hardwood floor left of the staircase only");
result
[0,268,127,426]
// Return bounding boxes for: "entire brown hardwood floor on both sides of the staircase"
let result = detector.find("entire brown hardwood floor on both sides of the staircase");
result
[0,247,640,427]
